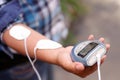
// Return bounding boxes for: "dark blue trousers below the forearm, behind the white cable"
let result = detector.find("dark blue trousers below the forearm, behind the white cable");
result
[0,61,52,80]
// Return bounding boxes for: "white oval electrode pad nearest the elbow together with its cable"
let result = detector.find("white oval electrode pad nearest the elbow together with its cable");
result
[9,25,41,80]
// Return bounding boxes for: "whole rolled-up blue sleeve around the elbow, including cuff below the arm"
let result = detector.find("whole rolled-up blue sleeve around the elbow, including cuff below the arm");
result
[0,0,22,58]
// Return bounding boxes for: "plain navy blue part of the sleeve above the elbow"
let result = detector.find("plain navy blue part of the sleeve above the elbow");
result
[0,0,22,32]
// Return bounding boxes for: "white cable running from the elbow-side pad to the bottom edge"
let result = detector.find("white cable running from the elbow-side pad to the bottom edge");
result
[24,38,41,80]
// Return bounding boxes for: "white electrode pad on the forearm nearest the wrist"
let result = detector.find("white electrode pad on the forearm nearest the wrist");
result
[36,39,62,49]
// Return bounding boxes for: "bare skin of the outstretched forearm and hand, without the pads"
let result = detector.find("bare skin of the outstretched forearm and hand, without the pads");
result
[3,24,110,78]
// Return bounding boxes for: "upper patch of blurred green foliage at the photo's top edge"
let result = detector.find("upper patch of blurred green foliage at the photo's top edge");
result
[60,0,86,18]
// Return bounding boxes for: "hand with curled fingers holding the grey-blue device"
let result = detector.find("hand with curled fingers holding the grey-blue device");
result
[57,35,110,78]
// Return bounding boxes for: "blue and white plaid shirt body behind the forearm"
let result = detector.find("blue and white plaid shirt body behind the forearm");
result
[0,0,68,57]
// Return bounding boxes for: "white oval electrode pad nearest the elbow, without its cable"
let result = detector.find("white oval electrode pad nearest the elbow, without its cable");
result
[10,25,31,40]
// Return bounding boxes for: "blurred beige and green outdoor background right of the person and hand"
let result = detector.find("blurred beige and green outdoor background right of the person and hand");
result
[53,0,120,80]
